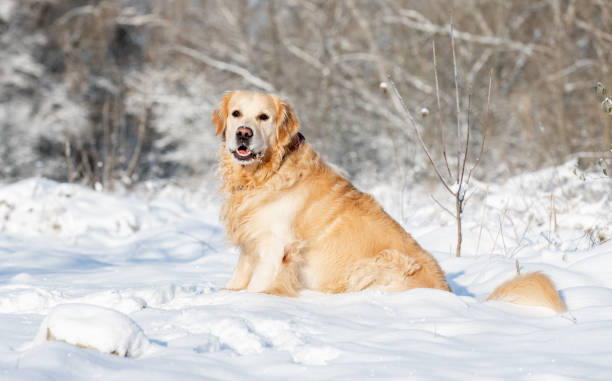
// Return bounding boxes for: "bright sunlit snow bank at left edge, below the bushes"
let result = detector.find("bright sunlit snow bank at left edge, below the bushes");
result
[0,178,198,238]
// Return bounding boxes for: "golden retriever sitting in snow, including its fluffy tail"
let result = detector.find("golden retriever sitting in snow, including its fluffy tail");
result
[212,91,565,311]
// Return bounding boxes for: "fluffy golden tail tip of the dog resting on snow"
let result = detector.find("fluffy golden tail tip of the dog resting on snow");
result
[487,272,567,312]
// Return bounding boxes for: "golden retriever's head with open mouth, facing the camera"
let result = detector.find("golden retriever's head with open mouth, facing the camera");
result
[212,91,299,165]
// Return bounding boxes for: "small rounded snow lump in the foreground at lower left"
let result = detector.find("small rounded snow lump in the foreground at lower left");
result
[34,304,151,357]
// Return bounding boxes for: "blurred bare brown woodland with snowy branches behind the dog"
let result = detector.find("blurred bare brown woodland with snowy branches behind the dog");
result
[0,0,612,190]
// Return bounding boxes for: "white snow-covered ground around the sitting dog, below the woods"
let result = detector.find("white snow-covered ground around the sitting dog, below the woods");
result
[0,163,612,380]
